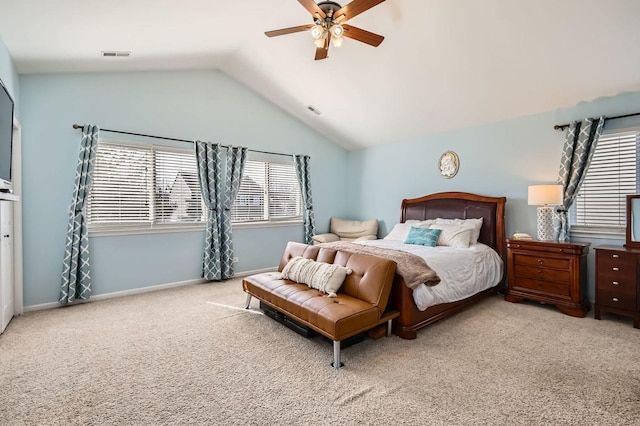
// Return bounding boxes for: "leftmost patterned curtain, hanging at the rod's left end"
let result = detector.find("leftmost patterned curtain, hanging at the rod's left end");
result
[58,124,100,304]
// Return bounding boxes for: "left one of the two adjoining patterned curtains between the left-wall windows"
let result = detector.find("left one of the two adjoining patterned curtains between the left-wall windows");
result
[195,141,224,280]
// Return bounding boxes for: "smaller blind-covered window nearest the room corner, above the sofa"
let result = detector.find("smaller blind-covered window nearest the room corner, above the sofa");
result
[231,160,302,223]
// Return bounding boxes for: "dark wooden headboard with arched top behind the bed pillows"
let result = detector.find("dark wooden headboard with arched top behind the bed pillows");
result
[400,192,507,259]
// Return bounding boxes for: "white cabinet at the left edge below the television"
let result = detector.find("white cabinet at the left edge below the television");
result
[0,200,15,333]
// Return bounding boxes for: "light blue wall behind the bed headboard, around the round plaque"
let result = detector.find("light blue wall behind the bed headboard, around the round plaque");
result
[349,93,640,299]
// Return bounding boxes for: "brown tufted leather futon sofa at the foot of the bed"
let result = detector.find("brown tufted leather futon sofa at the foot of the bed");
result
[242,242,398,369]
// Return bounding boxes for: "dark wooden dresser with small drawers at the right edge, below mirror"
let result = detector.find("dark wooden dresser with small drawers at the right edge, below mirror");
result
[593,246,640,328]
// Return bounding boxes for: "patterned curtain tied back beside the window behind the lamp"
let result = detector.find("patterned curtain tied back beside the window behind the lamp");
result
[554,117,605,241]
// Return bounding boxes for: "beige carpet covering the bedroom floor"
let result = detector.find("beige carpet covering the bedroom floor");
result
[0,279,640,425]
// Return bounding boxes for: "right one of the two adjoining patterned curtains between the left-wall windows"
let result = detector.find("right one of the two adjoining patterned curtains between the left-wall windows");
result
[220,147,247,279]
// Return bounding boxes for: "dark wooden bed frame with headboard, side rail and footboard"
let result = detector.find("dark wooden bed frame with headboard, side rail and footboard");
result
[393,192,507,339]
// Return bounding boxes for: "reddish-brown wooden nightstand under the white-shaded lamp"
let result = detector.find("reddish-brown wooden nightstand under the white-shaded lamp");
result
[504,240,591,317]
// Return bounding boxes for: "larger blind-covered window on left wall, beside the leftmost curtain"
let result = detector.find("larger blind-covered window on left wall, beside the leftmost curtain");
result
[87,140,206,231]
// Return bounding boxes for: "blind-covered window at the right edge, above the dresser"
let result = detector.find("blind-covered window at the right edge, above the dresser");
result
[570,130,640,234]
